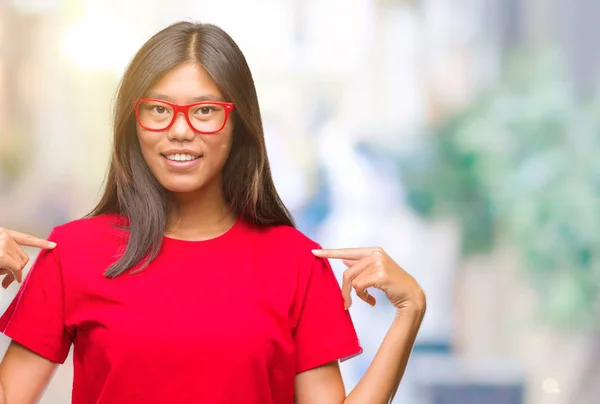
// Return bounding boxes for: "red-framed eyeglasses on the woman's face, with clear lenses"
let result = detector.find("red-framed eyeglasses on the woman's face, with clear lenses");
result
[135,98,234,135]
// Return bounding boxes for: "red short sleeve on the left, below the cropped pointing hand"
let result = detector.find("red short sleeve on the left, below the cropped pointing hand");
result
[0,232,72,363]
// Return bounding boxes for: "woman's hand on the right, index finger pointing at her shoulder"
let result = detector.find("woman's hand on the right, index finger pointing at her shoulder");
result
[313,247,425,311]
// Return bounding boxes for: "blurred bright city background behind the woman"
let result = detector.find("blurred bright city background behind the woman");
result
[0,0,600,404]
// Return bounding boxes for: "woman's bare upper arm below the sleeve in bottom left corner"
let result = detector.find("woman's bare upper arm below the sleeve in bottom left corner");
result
[0,341,57,404]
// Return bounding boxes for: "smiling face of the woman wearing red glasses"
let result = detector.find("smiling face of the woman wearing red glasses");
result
[137,62,233,193]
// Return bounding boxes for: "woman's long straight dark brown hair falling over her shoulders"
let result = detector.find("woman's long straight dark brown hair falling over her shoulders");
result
[88,22,294,278]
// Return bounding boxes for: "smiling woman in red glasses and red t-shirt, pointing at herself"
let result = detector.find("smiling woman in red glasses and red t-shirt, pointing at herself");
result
[0,22,425,404]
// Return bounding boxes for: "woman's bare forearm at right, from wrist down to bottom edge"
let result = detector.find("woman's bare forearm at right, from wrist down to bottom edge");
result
[344,297,425,404]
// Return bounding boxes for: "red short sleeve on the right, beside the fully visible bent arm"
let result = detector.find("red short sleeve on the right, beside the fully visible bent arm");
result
[294,251,362,373]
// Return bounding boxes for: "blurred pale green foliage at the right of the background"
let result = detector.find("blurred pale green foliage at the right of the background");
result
[400,51,600,329]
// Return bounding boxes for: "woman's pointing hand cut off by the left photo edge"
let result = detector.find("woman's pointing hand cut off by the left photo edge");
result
[0,227,56,289]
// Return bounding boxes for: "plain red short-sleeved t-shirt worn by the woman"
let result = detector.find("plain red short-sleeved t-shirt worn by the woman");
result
[0,215,361,404]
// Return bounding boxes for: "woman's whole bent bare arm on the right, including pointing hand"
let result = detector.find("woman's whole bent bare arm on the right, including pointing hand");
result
[295,248,426,404]
